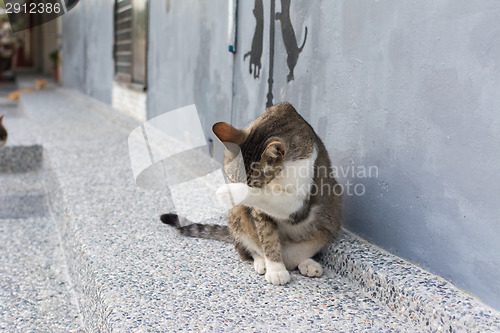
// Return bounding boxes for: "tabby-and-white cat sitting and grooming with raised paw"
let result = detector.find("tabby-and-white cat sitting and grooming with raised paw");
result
[160,103,342,285]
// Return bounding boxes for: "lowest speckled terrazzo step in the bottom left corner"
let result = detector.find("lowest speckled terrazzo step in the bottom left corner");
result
[0,214,81,333]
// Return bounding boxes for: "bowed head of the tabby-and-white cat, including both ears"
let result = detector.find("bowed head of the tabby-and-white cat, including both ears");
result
[212,103,310,187]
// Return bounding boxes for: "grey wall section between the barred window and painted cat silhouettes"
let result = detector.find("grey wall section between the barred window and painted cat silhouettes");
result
[147,0,233,158]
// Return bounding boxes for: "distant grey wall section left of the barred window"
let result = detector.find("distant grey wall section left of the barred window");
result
[62,0,114,103]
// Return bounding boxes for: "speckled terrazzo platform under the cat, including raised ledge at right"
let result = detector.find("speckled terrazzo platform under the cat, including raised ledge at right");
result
[14,89,500,332]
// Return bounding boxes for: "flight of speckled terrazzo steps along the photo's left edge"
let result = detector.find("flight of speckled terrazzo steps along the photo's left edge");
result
[0,91,81,333]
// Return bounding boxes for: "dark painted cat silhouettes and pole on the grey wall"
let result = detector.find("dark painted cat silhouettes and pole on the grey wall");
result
[243,0,307,107]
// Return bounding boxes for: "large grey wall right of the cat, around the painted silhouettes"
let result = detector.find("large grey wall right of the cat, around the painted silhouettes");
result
[233,0,500,308]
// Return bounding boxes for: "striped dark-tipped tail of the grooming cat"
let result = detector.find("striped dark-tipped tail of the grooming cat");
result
[160,214,233,243]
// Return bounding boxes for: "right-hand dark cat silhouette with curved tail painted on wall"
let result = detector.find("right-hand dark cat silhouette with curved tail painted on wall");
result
[276,0,307,82]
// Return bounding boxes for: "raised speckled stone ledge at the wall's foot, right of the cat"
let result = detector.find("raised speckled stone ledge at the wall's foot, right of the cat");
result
[322,231,500,332]
